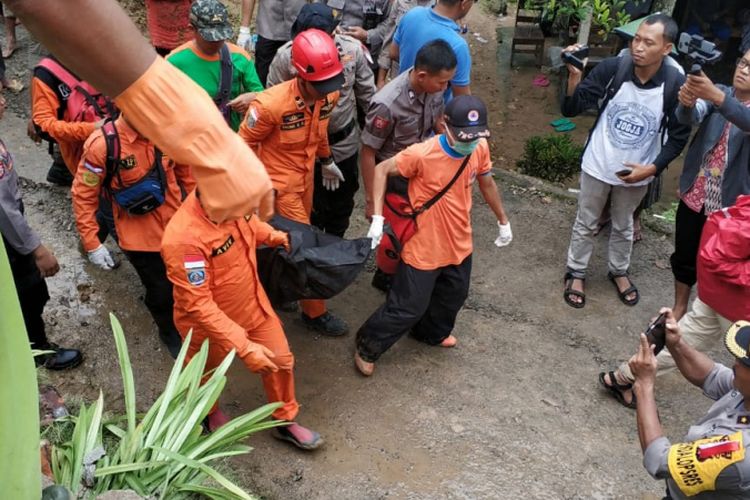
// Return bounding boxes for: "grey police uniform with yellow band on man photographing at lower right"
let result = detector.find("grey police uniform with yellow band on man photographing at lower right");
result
[643,362,750,500]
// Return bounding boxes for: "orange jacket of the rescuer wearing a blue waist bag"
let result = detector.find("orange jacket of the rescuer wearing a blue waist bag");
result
[71,117,195,252]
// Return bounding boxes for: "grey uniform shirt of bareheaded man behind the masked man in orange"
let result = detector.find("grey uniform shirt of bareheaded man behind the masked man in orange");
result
[362,67,444,162]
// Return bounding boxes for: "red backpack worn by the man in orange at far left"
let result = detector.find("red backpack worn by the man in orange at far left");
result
[34,57,118,142]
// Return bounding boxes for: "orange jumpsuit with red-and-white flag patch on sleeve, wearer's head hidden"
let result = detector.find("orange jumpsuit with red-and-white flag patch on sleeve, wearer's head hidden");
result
[161,191,299,420]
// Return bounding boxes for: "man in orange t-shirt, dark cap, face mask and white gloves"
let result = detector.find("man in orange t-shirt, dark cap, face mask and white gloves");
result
[354,96,513,376]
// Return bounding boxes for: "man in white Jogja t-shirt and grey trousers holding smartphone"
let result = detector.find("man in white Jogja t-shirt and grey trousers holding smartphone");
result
[562,14,690,308]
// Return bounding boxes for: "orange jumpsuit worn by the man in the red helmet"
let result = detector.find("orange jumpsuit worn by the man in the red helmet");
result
[239,78,339,318]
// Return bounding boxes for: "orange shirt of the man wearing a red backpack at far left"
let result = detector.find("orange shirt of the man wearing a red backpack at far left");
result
[31,77,96,175]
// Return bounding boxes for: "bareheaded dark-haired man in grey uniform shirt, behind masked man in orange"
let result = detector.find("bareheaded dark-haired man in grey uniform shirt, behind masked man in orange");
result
[360,40,456,292]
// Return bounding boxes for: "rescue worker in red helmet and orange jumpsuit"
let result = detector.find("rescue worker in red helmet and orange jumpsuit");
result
[239,29,349,336]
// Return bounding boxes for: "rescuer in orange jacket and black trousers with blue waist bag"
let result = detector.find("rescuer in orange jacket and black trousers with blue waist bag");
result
[71,115,195,358]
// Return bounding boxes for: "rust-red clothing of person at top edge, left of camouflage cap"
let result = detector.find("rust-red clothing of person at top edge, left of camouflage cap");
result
[146,0,194,50]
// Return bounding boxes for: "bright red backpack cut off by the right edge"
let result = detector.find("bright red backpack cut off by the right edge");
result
[698,195,750,322]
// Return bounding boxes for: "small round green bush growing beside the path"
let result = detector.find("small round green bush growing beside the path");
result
[516,135,583,182]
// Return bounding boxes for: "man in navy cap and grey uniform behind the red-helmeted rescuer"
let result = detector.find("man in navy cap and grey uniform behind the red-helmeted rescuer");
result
[268,3,375,237]
